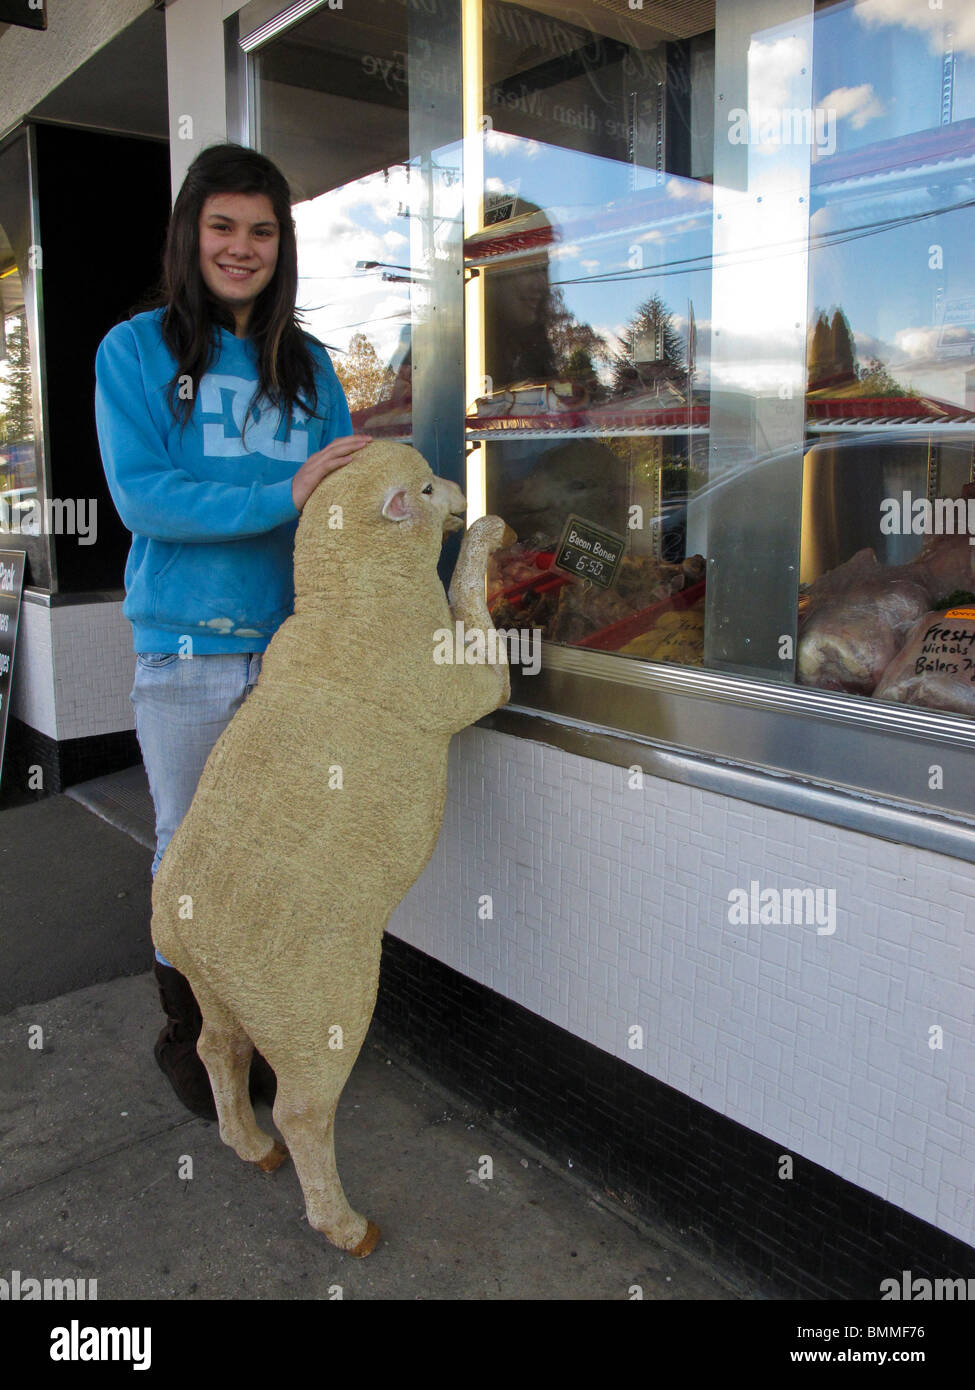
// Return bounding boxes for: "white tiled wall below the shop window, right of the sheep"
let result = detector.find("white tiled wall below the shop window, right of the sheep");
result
[389,728,975,1245]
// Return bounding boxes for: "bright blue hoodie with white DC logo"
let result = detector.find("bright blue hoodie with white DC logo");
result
[95,309,352,655]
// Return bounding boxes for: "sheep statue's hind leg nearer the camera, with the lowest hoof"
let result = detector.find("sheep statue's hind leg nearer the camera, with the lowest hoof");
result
[274,1067,380,1257]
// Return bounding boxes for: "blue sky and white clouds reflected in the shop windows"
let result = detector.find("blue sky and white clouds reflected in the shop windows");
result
[295,0,975,396]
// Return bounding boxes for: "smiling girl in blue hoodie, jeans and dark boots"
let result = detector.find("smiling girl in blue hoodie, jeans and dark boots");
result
[95,145,369,1118]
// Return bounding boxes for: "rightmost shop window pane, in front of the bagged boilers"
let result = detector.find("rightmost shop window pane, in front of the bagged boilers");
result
[797,3,975,716]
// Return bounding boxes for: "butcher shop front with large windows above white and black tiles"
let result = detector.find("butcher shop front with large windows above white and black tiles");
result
[0,0,975,1297]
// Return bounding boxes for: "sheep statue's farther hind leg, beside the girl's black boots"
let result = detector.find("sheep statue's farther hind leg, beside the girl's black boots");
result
[192,980,288,1173]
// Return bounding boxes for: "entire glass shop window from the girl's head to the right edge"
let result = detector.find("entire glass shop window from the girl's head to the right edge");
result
[246,0,975,809]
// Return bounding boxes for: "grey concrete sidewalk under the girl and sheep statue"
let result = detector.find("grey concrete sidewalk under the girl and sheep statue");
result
[0,796,764,1300]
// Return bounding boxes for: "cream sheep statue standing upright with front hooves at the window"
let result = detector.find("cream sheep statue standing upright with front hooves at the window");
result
[152,442,515,1255]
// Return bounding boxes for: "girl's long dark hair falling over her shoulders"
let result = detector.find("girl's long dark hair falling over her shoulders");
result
[139,143,319,430]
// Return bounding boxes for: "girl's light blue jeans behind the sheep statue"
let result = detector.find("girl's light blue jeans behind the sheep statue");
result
[129,652,261,965]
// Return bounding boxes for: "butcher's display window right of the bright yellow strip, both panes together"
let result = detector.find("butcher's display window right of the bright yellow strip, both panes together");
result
[465,0,975,733]
